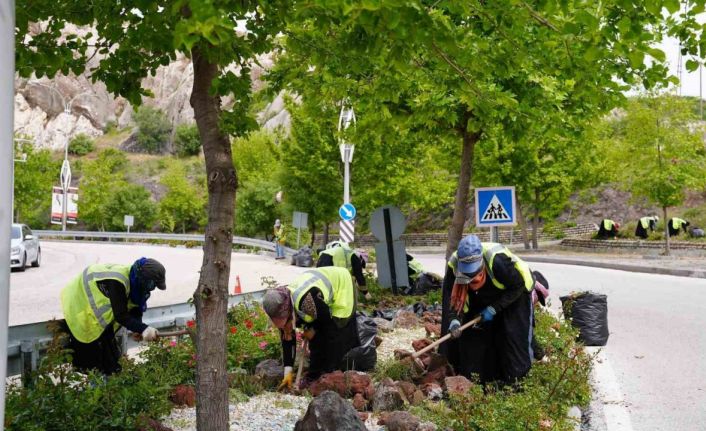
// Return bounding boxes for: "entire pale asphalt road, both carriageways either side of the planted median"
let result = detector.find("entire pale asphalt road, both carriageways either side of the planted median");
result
[10,245,706,431]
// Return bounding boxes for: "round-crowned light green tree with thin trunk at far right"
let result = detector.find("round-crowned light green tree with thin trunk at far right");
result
[606,95,706,254]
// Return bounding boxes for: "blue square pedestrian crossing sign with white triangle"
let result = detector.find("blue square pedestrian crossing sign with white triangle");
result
[476,186,517,227]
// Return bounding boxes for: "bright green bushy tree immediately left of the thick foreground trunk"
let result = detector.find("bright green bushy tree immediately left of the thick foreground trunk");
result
[159,163,206,233]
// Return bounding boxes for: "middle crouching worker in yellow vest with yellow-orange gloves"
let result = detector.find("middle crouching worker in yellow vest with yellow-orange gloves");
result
[262,267,374,388]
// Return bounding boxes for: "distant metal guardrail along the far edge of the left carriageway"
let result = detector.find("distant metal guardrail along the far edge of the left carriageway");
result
[33,230,296,255]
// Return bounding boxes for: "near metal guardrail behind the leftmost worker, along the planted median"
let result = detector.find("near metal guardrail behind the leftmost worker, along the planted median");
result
[7,290,265,377]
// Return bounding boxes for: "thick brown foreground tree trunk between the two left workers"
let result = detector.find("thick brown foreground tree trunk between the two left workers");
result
[191,48,238,431]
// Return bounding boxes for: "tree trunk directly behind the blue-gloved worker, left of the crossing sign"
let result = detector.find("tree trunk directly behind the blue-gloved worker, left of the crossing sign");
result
[446,120,480,259]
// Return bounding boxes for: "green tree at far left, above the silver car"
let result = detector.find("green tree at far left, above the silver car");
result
[14,142,61,228]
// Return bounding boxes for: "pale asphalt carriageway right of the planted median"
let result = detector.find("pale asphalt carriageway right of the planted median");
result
[418,255,706,431]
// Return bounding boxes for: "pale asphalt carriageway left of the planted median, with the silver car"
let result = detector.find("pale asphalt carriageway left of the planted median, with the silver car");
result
[10,241,304,325]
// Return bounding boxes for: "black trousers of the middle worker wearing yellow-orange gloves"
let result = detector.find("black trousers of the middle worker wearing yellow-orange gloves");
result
[307,315,360,379]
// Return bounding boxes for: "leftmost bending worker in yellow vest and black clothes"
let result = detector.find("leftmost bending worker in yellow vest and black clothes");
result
[61,257,167,375]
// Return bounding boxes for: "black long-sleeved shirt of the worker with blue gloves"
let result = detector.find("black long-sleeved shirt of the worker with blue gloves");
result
[444,254,525,320]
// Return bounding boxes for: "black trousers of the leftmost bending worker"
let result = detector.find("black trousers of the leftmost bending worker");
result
[64,324,121,375]
